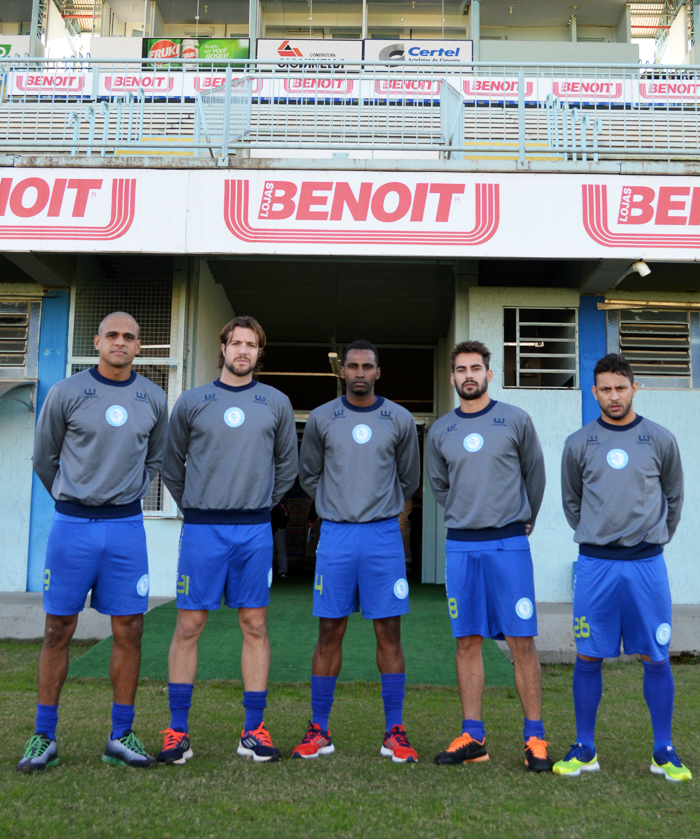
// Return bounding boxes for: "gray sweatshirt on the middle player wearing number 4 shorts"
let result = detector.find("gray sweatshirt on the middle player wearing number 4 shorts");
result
[299,396,420,524]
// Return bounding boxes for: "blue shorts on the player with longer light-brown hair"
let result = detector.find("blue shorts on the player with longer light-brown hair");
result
[177,521,272,611]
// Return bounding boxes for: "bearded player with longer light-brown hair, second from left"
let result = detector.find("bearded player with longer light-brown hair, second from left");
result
[158,316,298,764]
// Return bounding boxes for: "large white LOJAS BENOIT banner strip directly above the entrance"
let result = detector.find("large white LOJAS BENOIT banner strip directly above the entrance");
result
[0,168,700,261]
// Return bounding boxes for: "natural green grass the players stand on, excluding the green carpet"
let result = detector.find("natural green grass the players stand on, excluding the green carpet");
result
[0,642,700,839]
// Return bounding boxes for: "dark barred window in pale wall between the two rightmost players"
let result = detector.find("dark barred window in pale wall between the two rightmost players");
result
[503,307,578,388]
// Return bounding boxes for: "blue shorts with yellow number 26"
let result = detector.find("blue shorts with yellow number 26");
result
[574,554,672,661]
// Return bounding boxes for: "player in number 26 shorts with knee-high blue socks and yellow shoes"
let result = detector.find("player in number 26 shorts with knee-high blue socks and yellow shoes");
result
[554,353,692,781]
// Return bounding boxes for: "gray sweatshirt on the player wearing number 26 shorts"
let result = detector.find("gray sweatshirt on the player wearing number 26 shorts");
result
[561,416,683,559]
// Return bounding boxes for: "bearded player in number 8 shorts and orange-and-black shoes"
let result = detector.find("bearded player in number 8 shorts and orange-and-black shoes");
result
[427,341,552,772]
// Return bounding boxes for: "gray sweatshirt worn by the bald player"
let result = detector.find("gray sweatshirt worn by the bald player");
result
[32,367,168,518]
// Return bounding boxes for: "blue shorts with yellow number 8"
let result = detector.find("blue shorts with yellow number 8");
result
[445,536,537,640]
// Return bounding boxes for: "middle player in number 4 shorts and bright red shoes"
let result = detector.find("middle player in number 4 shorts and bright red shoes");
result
[292,340,420,763]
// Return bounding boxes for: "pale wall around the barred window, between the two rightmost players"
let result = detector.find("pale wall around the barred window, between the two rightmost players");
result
[469,288,581,602]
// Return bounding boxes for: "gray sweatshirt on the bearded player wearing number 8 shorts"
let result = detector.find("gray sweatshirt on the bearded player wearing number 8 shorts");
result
[427,399,545,541]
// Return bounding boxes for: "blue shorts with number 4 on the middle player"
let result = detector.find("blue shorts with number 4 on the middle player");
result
[314,519,408,620]
